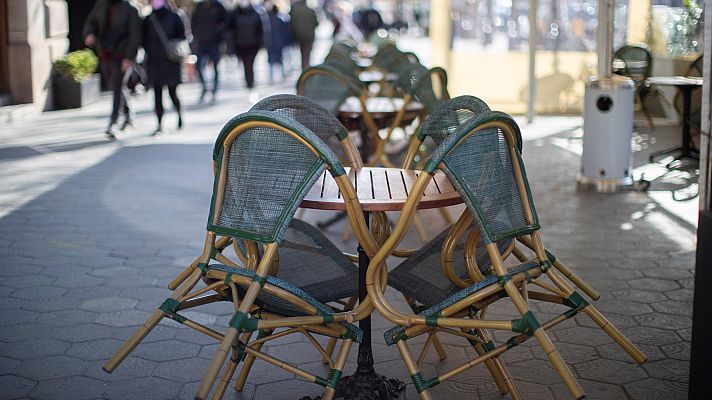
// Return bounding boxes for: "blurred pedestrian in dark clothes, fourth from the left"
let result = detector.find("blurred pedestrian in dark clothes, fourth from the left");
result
[229,0,263,89]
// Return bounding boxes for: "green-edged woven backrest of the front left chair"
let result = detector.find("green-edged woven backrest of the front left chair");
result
[207,110,345,243]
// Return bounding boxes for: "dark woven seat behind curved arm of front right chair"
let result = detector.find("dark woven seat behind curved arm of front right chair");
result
[388,228,511,307]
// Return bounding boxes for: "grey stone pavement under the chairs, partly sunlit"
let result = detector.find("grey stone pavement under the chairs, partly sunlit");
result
[0,49,695,400]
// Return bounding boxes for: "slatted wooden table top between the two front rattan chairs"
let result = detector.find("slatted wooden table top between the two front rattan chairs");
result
[301,167,462,211]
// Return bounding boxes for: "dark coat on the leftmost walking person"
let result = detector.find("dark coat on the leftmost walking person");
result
[82,0,141,60]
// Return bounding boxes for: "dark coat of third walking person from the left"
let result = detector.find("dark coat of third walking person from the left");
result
[190,0,227,48]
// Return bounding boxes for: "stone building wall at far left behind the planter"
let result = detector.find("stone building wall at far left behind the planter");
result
[7,0,69,110]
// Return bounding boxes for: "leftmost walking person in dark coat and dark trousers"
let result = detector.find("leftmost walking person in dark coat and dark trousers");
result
[82,0,141,139]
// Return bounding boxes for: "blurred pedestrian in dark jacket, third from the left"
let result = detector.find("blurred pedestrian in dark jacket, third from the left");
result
[191,0,227,102]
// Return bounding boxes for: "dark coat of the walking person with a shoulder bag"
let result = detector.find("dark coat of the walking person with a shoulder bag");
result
[143,7,185,86]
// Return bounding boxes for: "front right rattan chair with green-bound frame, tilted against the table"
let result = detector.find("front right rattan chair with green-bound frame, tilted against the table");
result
[366,111,646,399]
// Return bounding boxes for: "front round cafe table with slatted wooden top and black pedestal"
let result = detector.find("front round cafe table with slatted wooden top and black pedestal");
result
[301,167,462,400]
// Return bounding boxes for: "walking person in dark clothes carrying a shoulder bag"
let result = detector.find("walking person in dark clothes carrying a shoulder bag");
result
[143,0,185,135]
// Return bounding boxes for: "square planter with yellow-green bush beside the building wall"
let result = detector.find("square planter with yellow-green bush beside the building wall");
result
[52,50,100,109]
